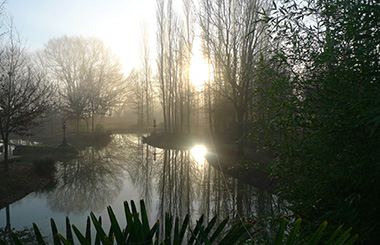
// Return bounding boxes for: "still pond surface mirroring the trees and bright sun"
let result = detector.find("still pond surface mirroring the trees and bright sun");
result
[0,134,282,242]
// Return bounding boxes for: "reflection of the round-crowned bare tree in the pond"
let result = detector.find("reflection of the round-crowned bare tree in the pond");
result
[43,138,124,214]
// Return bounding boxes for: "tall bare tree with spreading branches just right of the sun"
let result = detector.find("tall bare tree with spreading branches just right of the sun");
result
[200,0,268,153]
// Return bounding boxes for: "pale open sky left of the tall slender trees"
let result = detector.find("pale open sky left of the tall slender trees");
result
[5,0,156,72]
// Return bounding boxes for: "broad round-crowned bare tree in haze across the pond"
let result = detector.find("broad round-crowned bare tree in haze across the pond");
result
[43,36,124,131]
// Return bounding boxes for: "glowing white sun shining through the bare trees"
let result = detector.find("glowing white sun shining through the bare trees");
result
[190,56,210,89]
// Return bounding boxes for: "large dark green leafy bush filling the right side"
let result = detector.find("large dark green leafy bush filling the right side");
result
[255,0,380,241]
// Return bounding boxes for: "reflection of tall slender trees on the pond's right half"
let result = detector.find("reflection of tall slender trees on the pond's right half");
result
[151,146,282,234]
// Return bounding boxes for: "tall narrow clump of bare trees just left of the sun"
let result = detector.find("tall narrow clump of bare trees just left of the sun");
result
[157,0,194,132]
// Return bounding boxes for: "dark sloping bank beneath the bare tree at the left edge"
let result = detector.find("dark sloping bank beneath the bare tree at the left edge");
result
[0,162,51,209]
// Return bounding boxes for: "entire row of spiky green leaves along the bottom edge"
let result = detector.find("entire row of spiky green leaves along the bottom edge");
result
[0,200,358,245]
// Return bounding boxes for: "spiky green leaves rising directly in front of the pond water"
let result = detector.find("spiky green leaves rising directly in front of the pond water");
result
[0,200,253,244]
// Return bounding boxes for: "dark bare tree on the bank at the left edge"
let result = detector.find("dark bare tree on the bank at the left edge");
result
[0,25,52,172]
